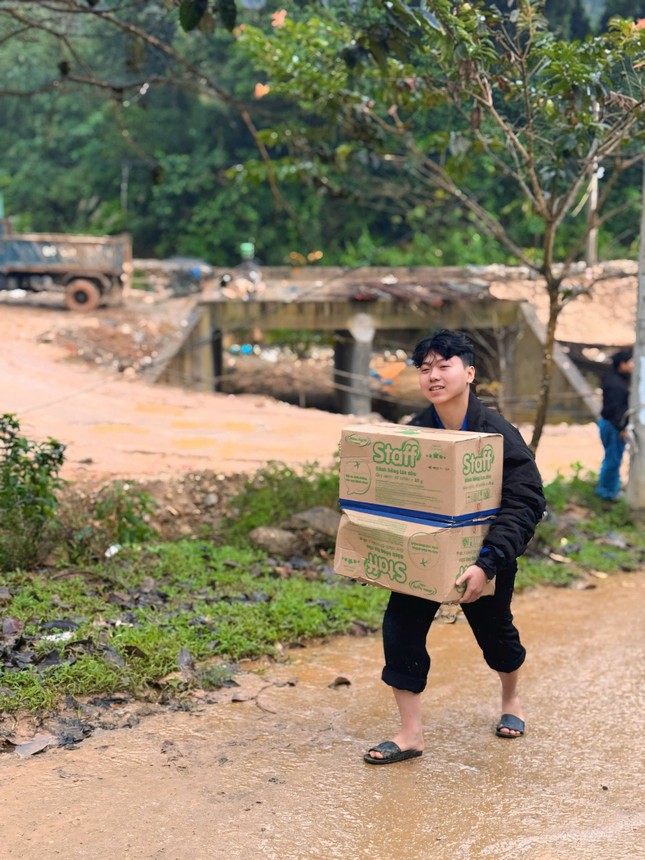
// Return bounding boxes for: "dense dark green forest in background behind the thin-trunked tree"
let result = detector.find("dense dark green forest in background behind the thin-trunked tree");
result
[0,0,639,266]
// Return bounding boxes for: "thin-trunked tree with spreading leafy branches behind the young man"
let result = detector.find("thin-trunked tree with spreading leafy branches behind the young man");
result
[240,0,645,450]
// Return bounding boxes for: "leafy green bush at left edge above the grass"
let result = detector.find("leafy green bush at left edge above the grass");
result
[0,414,65,571]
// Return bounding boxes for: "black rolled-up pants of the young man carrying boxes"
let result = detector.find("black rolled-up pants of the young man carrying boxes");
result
[381,573,526,693]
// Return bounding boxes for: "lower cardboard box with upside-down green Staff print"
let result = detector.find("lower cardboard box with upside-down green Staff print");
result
[334,511,495,603]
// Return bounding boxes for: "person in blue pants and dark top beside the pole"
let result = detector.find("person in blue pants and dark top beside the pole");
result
[596,349,634,502]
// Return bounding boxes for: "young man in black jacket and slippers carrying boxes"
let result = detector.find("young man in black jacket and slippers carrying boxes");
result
[337,330,545,764]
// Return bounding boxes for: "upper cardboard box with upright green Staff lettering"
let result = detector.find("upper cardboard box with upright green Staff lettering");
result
[340,424,504,519]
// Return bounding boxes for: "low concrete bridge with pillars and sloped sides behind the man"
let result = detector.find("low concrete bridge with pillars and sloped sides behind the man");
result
[146,266,620,422]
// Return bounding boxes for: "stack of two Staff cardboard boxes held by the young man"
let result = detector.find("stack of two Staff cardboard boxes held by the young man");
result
[334,424,503,603]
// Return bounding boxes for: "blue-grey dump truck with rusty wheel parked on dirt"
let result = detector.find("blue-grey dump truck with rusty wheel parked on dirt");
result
[0,219,132,313]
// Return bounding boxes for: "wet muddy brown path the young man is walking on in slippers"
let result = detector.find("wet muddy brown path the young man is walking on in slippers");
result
[0,572,645,860]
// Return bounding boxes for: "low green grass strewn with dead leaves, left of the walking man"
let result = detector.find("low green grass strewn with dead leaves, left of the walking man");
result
[0,540,387,711]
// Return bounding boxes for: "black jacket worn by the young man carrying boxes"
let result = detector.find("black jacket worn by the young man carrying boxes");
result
[410,391,546,579]
